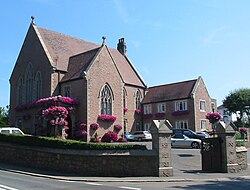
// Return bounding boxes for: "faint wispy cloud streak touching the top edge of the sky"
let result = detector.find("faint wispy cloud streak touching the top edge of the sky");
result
[113,0,138,24]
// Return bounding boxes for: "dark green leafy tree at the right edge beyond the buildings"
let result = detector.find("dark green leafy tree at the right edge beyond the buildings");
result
[223,88,250,125]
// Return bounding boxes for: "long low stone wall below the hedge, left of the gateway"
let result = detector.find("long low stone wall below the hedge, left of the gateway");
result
[0,142,159,177]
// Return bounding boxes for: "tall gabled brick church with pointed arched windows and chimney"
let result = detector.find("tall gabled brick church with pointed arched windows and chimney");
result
[10,20,146,140]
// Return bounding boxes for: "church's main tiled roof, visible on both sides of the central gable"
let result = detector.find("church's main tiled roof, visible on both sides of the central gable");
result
[35,26,146,87]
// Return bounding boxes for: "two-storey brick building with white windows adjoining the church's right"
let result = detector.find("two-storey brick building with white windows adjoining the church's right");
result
[142,77,217,131]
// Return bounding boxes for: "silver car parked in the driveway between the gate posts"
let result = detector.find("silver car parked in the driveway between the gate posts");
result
[171,134,201,148]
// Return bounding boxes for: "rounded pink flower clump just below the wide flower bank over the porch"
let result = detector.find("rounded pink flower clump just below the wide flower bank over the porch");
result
[42,106,69,118]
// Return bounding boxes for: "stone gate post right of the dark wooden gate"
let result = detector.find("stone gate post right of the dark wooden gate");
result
[216,121,239,173]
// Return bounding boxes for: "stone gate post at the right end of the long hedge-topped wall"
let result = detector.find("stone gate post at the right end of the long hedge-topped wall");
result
[150,120,173,177]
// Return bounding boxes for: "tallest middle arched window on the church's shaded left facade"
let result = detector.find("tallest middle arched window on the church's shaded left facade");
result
[25,63,33,103]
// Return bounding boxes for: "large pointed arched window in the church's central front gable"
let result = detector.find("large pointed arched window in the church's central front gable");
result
[101,84,113,115]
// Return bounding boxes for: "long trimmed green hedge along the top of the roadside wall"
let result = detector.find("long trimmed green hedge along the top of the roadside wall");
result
[0,134,146,150]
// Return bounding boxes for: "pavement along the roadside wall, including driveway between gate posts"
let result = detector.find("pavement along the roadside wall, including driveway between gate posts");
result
[0,149,250,182]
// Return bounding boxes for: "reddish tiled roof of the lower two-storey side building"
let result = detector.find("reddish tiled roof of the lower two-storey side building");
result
[142,79,197,104]
